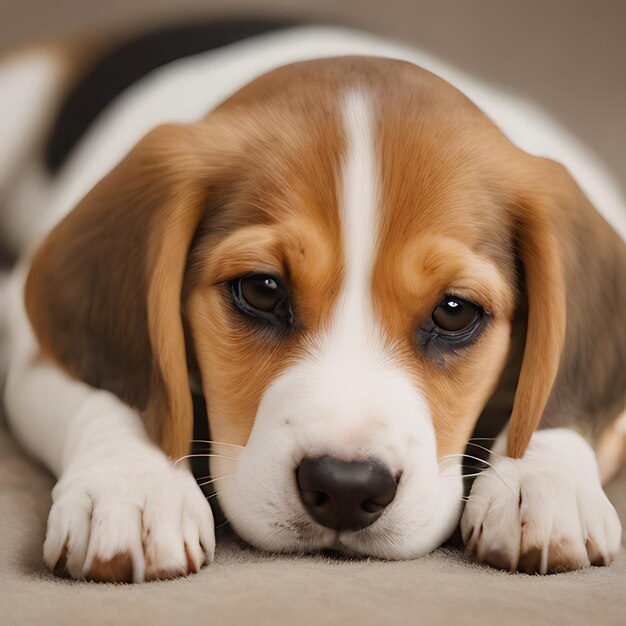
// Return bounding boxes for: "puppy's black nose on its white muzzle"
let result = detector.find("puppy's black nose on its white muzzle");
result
[296,456,398,530]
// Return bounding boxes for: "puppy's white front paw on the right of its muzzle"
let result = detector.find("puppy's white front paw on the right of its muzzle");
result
[461,431,621,574]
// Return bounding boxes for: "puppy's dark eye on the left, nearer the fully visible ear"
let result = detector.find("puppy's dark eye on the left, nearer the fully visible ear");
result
[231,274,293,322]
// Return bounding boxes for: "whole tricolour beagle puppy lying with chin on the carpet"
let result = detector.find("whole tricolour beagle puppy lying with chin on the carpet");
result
[0,26,626,582]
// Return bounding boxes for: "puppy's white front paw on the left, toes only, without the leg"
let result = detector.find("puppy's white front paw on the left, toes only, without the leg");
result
[44,455,215,582]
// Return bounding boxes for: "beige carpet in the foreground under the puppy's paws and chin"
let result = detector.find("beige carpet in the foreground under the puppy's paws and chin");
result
[0,408,626,626]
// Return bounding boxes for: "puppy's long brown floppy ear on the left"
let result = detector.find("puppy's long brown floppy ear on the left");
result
[25,124,223,457]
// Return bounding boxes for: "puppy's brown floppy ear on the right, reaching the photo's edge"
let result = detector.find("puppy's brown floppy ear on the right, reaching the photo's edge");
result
[508,157,626,458]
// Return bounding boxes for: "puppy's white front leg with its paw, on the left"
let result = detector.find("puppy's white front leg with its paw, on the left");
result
[5,268,214,582]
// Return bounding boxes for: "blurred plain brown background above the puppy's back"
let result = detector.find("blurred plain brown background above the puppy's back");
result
[0,0,626,190]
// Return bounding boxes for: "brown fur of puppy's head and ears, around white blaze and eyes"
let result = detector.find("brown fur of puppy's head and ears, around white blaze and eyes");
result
[26,58,624,472]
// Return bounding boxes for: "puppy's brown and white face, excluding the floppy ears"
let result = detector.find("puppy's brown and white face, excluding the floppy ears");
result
[186,64,514,558]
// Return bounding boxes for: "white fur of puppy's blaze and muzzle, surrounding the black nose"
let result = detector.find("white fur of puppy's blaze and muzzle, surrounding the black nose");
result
[211,92,462,558]
